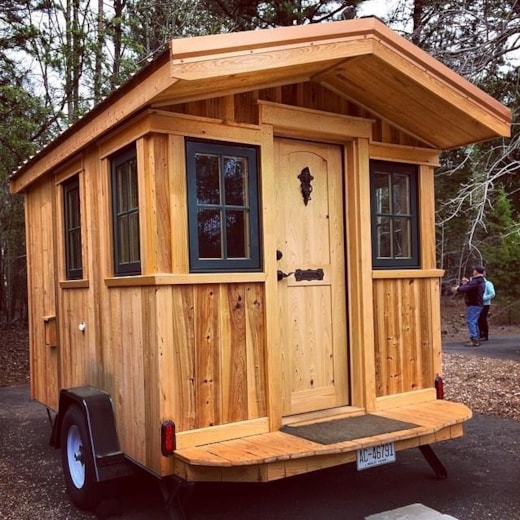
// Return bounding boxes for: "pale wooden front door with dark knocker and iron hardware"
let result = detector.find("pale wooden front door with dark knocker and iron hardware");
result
[275,139,349,415]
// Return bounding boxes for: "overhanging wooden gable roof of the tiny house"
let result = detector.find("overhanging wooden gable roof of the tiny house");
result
[11,18,511,191]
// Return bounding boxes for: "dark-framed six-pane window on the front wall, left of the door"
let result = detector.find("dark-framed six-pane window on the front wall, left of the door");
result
[186,141,261,272]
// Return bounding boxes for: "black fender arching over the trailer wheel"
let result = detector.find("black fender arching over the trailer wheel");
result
[50,386,134,482]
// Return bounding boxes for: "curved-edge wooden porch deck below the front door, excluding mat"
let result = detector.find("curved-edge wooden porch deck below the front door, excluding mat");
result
[175,400,472,482]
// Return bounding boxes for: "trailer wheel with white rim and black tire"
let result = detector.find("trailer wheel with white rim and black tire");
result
[61,405,101,509]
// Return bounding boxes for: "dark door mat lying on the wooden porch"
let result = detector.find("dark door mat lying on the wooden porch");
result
[281,414,418,444]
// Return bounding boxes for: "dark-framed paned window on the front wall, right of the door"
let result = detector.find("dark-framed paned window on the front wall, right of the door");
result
[370,161,419,268]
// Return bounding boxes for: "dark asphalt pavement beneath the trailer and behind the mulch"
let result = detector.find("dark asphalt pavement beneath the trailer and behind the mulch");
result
[0,337,520,520]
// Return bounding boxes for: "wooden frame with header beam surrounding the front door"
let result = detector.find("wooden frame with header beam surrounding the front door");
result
[259,102,375,431]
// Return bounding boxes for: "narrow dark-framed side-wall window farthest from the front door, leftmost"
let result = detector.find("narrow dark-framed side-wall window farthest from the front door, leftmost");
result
[62,175,83,280]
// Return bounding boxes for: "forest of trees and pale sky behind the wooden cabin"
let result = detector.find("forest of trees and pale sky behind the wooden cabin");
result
[0,0,520,325]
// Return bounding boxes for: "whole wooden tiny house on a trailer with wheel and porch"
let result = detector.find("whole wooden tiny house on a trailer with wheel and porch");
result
[11,18,510,505]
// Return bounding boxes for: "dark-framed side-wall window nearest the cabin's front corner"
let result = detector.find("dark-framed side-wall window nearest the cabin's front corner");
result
[111,147,141,276]
